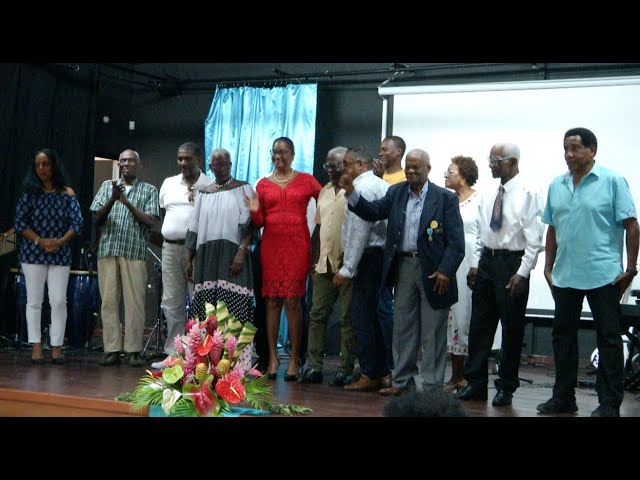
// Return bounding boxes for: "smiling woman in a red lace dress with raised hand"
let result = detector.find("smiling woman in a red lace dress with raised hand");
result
[246,137,322,382]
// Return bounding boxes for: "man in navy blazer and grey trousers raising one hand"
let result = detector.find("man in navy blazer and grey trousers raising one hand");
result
[341,149,464,396]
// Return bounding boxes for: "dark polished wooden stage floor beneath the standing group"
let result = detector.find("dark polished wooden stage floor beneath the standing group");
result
[0,345,640,418]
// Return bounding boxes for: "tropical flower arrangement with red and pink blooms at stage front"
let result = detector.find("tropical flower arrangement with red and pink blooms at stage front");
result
[130,302,272,416]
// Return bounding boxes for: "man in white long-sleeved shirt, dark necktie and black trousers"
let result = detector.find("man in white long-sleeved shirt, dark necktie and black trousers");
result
[457,143,544,407]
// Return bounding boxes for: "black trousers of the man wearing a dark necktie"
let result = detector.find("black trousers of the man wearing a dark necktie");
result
[464,250,529,393]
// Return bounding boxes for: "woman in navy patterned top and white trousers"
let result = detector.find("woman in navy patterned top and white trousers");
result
[15,148,82,364]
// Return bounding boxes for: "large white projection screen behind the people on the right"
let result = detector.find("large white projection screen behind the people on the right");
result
[378,76,640,316]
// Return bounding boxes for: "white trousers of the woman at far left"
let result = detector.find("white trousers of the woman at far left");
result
[21,263,71,347]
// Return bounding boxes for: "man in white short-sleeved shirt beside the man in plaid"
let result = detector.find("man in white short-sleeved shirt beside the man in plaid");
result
[151,142,213,369]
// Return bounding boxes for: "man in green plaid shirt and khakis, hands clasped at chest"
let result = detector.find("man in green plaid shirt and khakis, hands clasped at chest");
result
[90,149,160,367]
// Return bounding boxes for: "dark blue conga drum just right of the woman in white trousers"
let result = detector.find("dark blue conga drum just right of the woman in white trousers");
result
[66,270,100,348]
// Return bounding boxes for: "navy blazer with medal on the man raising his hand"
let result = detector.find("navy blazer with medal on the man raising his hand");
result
[349,181,464,308]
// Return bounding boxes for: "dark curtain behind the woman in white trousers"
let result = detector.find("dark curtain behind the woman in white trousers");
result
[0,63,97,329]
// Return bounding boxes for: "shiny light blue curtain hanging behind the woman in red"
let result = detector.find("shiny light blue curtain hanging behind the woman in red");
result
[204,84,318,185]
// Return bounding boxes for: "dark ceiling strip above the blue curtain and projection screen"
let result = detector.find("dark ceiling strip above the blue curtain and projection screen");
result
[74,63,640,95]
